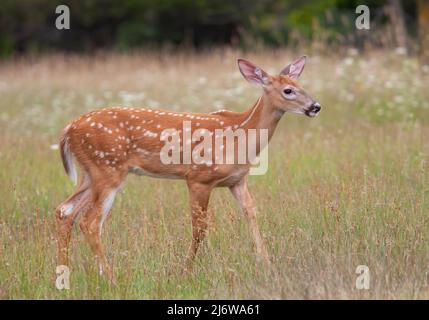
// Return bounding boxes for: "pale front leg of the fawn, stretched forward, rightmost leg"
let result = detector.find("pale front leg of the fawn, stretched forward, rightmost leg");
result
[230,178,270,265]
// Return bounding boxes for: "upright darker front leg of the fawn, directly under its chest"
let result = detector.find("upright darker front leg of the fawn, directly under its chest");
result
[185,182,212,272]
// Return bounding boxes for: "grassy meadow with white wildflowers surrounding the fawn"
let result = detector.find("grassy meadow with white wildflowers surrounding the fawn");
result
[0,50,429,299]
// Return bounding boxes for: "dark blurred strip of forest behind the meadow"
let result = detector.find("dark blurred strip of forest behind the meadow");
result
[0,0,429,60]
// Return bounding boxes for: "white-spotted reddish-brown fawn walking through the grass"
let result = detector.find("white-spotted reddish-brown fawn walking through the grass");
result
[56,57,320,280]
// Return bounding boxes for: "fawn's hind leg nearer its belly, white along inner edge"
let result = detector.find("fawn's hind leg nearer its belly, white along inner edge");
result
[79,180,119,282]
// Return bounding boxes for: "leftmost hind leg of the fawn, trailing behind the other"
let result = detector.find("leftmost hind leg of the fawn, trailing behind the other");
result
[55,175,91,265]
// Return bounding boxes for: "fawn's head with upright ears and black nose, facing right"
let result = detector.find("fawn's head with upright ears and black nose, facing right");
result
[238,56,321,117]
